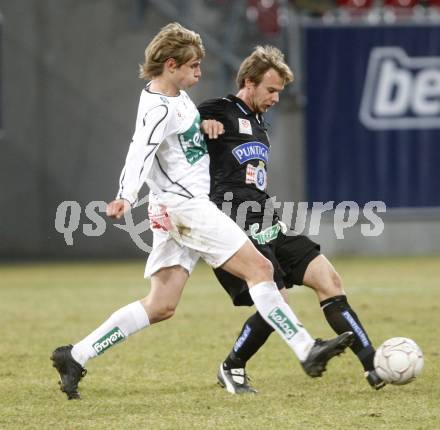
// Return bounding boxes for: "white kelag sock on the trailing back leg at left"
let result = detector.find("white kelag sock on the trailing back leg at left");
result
[71,301,150,367]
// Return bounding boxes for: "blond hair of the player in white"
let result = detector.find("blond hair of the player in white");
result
[139,22,205,80]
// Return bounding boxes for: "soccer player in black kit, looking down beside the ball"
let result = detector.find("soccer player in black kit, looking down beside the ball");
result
[199,46,385,394]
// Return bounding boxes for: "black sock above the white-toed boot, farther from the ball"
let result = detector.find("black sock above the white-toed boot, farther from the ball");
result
[223,312,274,369]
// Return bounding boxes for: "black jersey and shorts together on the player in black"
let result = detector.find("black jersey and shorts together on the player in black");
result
[198,95,319,306]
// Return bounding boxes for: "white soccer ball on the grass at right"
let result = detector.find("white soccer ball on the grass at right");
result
[374,337,423,385]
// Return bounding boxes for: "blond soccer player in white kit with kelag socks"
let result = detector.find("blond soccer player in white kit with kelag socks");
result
[51,23,353,399]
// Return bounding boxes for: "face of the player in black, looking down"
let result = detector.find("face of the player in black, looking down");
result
[250,69,284,113]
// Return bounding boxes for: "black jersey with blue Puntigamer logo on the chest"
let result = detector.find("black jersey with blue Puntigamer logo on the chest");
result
[198,95,276,227]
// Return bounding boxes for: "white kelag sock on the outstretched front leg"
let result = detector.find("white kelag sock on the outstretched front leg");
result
[249,282,315,361]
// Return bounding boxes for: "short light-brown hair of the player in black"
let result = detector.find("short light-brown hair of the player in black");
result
[235,45,293,89]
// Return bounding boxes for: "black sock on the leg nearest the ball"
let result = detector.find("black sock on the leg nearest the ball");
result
[321,296,375,370]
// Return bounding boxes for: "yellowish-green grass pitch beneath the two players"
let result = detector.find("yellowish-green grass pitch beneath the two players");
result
[0,257,440,430]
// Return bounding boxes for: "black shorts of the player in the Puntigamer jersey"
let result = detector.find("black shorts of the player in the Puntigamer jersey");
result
[214,232,321,306]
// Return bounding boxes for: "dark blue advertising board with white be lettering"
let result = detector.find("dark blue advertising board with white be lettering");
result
[304,25,440,207]
